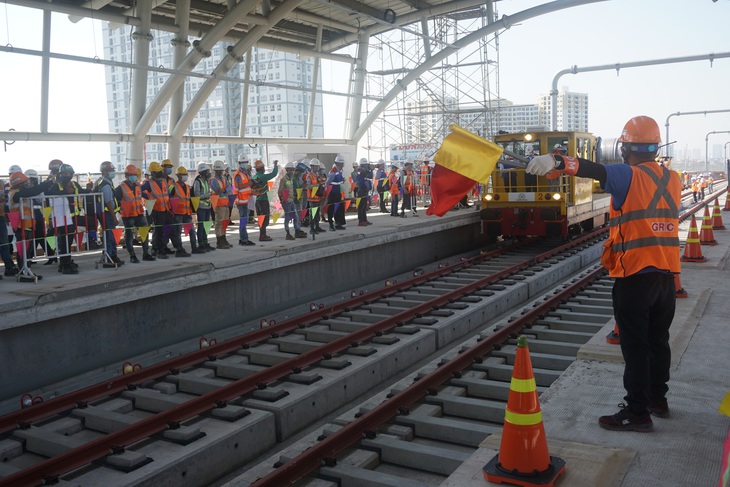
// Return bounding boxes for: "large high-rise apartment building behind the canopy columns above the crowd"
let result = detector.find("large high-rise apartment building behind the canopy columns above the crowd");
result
[103,25,324,169]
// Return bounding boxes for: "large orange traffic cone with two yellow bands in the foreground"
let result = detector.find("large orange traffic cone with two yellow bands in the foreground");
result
[482,336,565,487]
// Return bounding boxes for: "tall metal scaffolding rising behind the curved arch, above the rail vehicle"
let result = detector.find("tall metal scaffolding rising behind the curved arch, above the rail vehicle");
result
[361,2,500,160]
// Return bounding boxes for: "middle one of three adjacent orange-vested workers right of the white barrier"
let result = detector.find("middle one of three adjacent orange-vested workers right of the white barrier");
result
[142,161,190,259]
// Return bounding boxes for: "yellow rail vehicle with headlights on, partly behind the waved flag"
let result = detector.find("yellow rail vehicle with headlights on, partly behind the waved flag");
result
[480,132,620,240]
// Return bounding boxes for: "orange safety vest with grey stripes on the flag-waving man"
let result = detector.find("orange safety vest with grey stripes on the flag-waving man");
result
[601,162,682,277]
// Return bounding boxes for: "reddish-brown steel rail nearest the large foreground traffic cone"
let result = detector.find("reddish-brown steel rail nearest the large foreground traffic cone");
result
[251,268,606,487]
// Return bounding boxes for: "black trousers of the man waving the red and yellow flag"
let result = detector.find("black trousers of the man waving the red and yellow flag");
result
[612,272,676,415]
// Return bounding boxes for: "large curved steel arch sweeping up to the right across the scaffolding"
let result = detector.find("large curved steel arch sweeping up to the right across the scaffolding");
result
[350,0,606,144]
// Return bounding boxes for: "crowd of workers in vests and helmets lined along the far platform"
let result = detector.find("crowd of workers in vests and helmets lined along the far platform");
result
[0,154,440,276]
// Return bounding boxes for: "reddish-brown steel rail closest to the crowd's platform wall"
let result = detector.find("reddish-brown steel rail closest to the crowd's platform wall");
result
[0,246,519,433]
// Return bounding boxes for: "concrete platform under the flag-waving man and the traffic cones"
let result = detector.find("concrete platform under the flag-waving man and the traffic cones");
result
[441,198,730,487]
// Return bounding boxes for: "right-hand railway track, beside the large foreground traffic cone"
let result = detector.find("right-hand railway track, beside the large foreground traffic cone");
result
[239,267,613,487]
